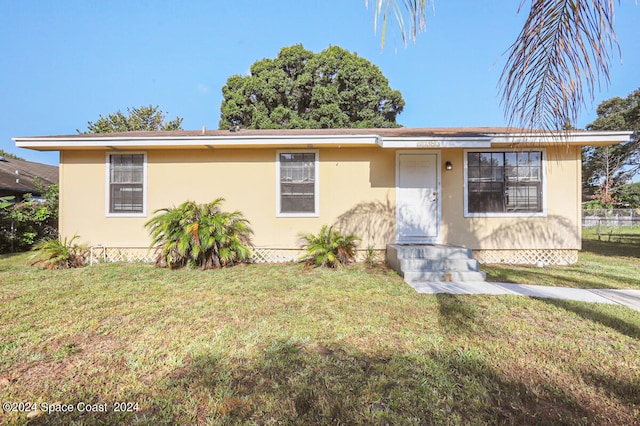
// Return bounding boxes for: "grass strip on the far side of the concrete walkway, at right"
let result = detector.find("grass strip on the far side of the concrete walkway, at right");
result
[482,228,640,289]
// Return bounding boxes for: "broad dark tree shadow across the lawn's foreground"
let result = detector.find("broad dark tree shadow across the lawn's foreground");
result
[152,340,604,425]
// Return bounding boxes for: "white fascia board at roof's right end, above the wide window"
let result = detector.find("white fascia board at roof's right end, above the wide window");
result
[491,131,633,145]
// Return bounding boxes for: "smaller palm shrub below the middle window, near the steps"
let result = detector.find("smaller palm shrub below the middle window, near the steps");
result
[300,225,360,268]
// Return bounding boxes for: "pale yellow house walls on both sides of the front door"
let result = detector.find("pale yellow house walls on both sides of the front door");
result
[60,146,581,256]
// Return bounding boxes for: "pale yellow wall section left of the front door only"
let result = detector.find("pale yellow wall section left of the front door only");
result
[60,148,395,249]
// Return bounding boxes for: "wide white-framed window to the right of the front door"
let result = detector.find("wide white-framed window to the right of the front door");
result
[466,151,543,214]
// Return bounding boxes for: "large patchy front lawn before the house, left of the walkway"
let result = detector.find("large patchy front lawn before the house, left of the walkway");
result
[0,251,640,425]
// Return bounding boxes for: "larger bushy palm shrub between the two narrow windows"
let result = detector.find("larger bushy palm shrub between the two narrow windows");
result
[145,198,252,270]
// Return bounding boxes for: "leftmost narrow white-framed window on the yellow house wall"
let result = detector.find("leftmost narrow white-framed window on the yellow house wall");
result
[107,154,146,215]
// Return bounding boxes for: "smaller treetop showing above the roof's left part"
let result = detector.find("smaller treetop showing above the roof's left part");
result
[78,105,183,133]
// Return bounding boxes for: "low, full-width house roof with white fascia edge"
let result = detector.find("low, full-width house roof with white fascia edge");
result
[13,127,631,151]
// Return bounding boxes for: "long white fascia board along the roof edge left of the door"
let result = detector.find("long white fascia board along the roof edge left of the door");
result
[13,135,378,150]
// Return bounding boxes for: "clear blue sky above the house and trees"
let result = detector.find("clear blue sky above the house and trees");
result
[0,0,640,164]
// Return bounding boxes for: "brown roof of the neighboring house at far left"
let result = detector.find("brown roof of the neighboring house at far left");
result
[0,157,58,194]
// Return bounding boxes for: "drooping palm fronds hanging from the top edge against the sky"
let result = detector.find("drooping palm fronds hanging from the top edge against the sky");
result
[365,0,619,130]
